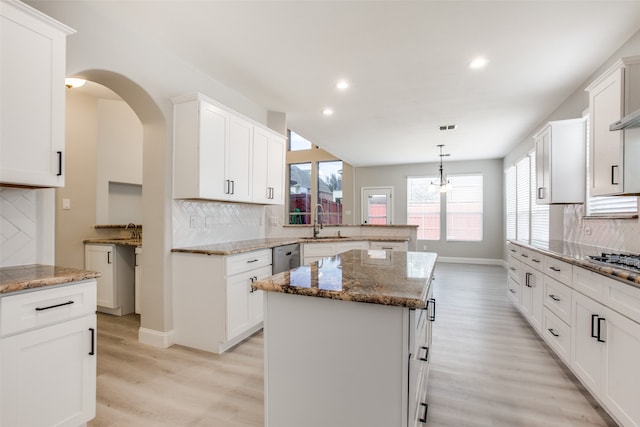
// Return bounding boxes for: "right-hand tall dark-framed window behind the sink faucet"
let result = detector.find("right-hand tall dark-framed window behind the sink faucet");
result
[317,160,342,224]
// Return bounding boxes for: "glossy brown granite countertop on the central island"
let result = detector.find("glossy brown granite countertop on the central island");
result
[252,249,438,308]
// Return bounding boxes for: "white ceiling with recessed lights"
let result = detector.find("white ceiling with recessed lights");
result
[65,0,640,166]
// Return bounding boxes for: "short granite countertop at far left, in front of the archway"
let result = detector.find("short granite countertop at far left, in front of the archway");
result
[0,264,100,296]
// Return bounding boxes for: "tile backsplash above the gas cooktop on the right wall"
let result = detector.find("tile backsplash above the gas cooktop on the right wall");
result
[563,205,640,253]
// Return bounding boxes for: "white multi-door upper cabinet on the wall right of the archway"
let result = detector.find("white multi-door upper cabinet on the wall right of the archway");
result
[173,94,284,204]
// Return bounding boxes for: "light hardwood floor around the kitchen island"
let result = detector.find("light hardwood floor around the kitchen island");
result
[89,264,615,427]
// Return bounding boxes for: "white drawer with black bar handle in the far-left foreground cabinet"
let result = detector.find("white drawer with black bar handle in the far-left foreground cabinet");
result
[0,280,96,336]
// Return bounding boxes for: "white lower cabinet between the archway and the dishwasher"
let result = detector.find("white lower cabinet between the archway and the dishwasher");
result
[173,249,271,353]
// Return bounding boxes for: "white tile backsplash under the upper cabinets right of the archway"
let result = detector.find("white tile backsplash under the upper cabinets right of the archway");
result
[172,200,265,248]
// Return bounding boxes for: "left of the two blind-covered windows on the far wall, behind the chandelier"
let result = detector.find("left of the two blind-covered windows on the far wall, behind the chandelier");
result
[407,176,440,240]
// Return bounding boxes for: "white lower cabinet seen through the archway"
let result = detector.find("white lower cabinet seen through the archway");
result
[84,244,136,316]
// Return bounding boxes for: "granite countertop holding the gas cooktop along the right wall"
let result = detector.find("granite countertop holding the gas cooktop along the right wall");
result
[512,240,640,288]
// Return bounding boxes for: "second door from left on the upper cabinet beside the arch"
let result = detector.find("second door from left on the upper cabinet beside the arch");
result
[225,115,253,202]
